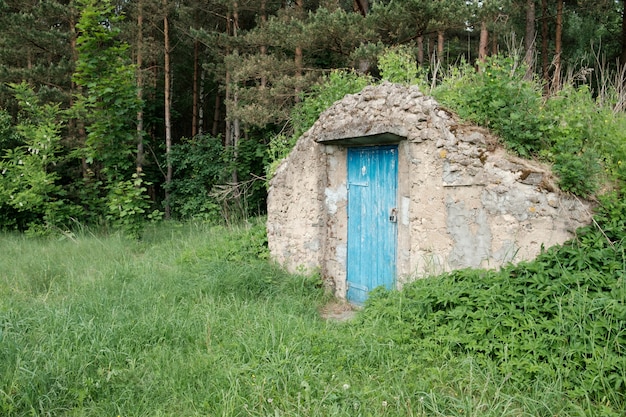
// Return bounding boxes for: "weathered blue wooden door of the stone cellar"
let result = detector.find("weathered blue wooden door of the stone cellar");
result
[347,146,398,304]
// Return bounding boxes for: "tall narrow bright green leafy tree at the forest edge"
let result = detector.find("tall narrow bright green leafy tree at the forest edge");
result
[66,0,152,237]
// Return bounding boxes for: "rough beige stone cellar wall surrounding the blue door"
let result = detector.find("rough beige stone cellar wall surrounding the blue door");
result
[267,83,591,297]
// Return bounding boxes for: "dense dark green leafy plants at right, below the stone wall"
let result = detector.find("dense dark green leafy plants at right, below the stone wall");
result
[363,195,626,415]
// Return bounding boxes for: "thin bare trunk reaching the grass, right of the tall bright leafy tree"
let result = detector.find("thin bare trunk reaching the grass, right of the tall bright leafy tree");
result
[163,0,173,219]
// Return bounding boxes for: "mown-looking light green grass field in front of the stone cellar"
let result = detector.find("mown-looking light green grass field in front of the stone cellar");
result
[0,221,623,417]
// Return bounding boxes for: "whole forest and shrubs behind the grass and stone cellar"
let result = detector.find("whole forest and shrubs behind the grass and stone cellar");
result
[0,0,626,235]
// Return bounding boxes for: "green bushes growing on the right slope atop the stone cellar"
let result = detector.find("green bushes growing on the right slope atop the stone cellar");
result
[434,57,626,197]
